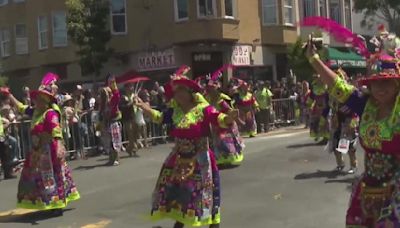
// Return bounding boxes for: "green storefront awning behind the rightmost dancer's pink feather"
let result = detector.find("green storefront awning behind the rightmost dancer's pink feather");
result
[327,47,367,68]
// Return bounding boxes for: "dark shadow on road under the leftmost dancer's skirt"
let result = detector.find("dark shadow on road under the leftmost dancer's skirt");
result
[0,209,74,226]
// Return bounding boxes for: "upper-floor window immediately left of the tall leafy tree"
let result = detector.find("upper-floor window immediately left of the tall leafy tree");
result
[53,11,67,47]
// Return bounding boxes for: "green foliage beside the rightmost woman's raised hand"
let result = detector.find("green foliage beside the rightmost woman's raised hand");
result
[287,35,326,81]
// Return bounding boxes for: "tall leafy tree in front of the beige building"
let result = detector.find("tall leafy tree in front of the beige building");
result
[66,0,113,78]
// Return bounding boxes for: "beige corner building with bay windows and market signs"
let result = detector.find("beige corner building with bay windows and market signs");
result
[0,0,351,89]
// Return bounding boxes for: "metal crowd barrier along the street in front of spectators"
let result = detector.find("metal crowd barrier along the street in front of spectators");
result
[4,98,296,160]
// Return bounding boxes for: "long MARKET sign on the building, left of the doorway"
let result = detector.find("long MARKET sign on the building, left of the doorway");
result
[137,49,176,71]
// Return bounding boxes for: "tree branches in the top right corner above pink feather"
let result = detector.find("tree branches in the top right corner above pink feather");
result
[354,0,400,35]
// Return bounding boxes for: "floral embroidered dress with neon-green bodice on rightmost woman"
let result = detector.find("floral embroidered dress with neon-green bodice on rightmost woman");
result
[330,78,400,228]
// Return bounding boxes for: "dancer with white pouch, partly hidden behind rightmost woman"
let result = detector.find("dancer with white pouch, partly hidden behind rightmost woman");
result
[329,69,359,174]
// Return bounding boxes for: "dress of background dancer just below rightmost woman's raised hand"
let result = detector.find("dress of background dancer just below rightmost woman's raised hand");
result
[308,83,329,140]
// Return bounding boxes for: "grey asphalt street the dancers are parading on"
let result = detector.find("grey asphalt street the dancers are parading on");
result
[0,130,362,228]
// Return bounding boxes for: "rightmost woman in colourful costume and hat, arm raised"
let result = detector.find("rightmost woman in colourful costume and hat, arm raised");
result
[307,34,400,228]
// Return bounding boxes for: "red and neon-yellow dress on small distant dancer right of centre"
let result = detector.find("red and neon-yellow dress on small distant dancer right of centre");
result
[234,92,258,136]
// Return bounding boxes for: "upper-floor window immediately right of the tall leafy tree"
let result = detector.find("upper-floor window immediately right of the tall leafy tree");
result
[111,0,127,34]
